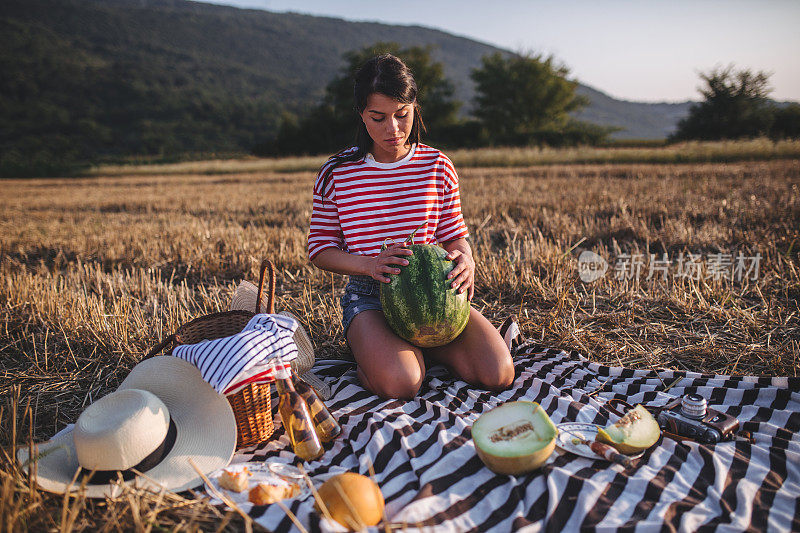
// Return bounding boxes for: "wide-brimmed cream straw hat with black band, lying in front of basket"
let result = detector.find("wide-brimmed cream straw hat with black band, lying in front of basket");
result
[17,356,236,498]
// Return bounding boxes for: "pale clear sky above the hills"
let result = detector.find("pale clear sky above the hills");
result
[197,0,800,102]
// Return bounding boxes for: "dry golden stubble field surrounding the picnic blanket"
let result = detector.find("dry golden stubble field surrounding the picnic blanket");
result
[0,159,800,531]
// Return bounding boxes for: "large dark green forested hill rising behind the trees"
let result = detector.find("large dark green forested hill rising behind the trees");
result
[0,0,692,174]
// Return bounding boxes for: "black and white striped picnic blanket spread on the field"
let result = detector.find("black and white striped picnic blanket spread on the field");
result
[231,345,800,531]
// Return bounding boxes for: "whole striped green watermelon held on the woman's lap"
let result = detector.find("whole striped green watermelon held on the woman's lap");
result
[381,244,469,348]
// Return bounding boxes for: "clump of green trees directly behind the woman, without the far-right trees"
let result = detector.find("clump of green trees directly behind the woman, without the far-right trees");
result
[254,43,615,156]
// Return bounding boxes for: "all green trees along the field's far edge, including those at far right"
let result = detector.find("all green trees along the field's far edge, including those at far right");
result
[266,43,800,156]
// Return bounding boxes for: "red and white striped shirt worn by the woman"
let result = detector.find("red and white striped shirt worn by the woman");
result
[308,144,468,259]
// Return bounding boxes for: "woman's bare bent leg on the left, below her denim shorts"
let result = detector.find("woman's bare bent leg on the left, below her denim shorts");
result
[347,310,425,399]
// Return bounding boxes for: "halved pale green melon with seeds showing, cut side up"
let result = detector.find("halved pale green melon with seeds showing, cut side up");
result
[472,401,558,475]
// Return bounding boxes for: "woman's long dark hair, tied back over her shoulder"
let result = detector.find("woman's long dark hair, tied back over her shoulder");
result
[321,54,425,191]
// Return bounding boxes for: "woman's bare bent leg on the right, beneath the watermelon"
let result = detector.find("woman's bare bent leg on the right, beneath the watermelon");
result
[425,307,514,391]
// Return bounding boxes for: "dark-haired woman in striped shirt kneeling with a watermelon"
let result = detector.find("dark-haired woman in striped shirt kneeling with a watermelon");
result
[308,54,514,399]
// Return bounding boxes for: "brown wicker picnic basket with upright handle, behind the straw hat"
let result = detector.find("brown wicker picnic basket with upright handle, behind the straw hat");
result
[146,259,275,448]
